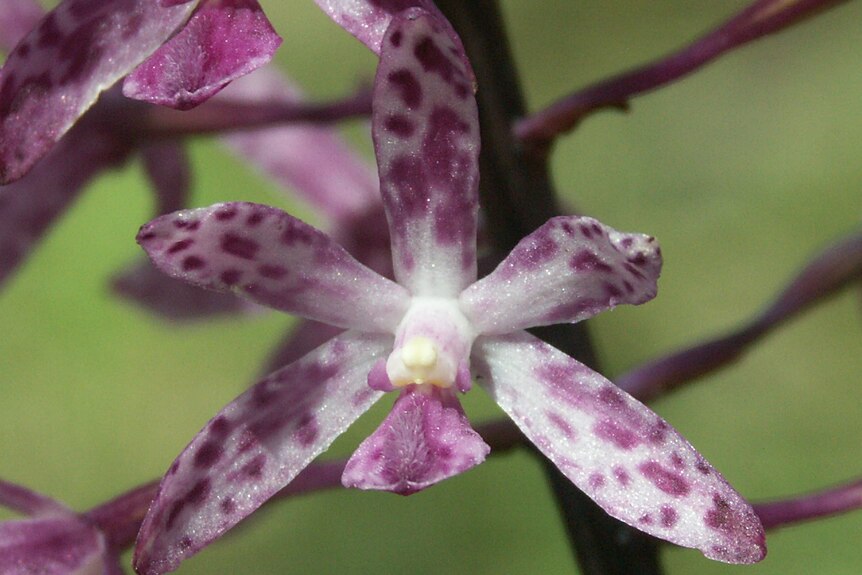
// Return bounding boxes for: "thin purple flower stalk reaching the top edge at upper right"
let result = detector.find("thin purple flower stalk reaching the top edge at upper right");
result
[515,0,847,147]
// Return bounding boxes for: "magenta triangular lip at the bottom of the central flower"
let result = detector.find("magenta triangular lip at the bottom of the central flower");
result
[341,386,491,495]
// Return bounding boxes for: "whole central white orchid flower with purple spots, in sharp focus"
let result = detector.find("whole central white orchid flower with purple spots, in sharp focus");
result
[135,9,765,575]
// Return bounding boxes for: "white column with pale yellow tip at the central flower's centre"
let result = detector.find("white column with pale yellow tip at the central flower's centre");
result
[386,297,475,388]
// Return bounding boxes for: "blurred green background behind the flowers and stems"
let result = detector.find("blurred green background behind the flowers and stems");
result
[0,0,862,575]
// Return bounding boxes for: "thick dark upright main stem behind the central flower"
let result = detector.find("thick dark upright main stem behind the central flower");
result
[437,0,661,575]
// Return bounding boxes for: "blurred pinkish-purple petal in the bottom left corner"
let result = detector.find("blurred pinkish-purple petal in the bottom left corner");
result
[0,515,105,575]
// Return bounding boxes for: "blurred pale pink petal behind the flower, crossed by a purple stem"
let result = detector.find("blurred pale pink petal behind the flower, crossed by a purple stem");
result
[223,67,380,223]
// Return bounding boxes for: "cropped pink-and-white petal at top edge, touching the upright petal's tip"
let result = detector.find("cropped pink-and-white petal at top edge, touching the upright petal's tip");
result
[315,0,454,54]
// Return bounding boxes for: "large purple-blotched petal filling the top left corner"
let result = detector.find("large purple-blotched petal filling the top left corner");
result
[0,0,195,183]
